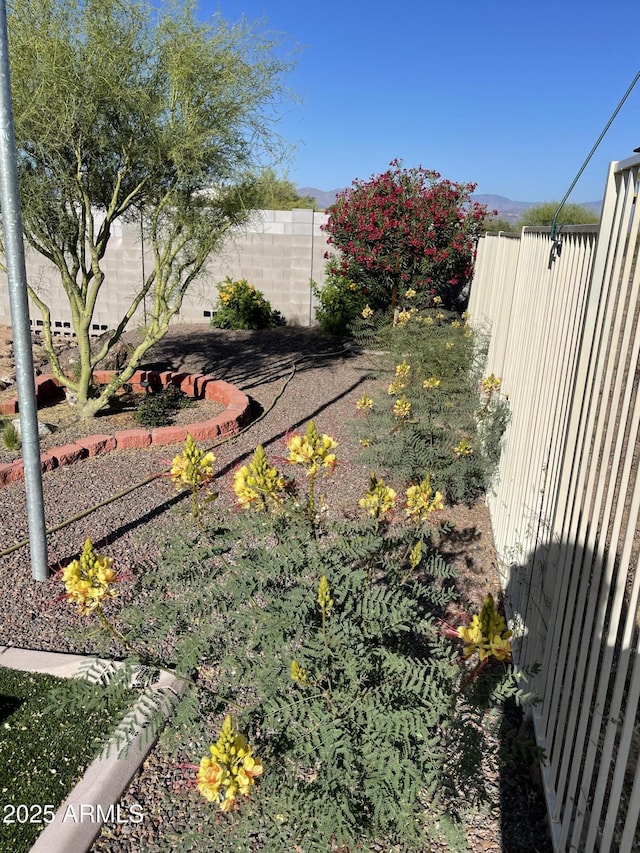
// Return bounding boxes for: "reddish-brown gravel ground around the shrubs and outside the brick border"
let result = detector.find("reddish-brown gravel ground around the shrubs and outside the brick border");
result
[0,326,551,853]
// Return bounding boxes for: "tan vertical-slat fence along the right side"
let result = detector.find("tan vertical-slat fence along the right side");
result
[469,150,640,853]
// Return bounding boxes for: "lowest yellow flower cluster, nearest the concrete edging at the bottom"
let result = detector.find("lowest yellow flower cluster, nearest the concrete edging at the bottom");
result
[198,714,263,812]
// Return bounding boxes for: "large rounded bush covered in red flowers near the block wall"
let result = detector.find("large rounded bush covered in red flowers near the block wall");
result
[324,160,487,311]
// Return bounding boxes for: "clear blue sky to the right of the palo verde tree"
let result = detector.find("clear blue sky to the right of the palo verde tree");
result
[208,0,640,202]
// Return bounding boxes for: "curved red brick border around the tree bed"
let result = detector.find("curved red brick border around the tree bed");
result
[0,370,251,488]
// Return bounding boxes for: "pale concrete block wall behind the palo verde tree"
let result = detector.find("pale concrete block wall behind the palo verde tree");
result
[0,209,328,335]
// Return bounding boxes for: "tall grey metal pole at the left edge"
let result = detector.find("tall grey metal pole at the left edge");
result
[0,0,49,581]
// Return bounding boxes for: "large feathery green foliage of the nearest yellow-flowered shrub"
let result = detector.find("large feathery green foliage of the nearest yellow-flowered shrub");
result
[62,486,519,853]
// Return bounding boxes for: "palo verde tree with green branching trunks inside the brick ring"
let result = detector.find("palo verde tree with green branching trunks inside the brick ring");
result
[8,0,288,418]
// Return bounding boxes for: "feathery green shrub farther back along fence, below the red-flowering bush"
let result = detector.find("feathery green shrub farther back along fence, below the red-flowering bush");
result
[354,310,509,504]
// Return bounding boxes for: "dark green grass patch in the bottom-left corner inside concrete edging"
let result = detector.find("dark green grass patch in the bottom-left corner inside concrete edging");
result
[0,667,132,853]
